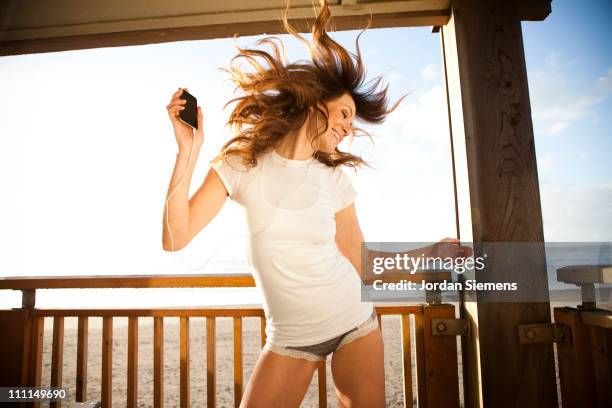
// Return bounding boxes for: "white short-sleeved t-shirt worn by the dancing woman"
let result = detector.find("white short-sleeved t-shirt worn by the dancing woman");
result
[212,149,374,346]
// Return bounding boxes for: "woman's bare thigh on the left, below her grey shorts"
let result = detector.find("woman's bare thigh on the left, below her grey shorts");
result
[240,350,319,408]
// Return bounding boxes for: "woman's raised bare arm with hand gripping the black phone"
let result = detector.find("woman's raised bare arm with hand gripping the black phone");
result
[162,89,228,251]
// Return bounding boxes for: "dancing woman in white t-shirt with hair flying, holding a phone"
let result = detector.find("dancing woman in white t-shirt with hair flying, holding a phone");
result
[163,1,466,407]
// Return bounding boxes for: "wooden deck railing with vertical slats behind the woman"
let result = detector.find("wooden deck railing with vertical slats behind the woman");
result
[0,273,459,407]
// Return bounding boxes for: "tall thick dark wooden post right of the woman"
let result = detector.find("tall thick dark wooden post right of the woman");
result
[442,0,557,407]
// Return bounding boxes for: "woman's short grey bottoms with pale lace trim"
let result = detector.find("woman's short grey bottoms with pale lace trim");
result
[263,309,378,361]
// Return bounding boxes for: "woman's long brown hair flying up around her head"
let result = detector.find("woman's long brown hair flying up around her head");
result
[211,0,406,167]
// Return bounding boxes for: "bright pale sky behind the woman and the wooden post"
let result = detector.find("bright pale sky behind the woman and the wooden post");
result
[0,0,612,307]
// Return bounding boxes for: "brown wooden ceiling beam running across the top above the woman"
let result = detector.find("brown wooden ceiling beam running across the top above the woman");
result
[0,0,550,56]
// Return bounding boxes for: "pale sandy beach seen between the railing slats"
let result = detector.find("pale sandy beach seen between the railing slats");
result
[35,316,456,408]
